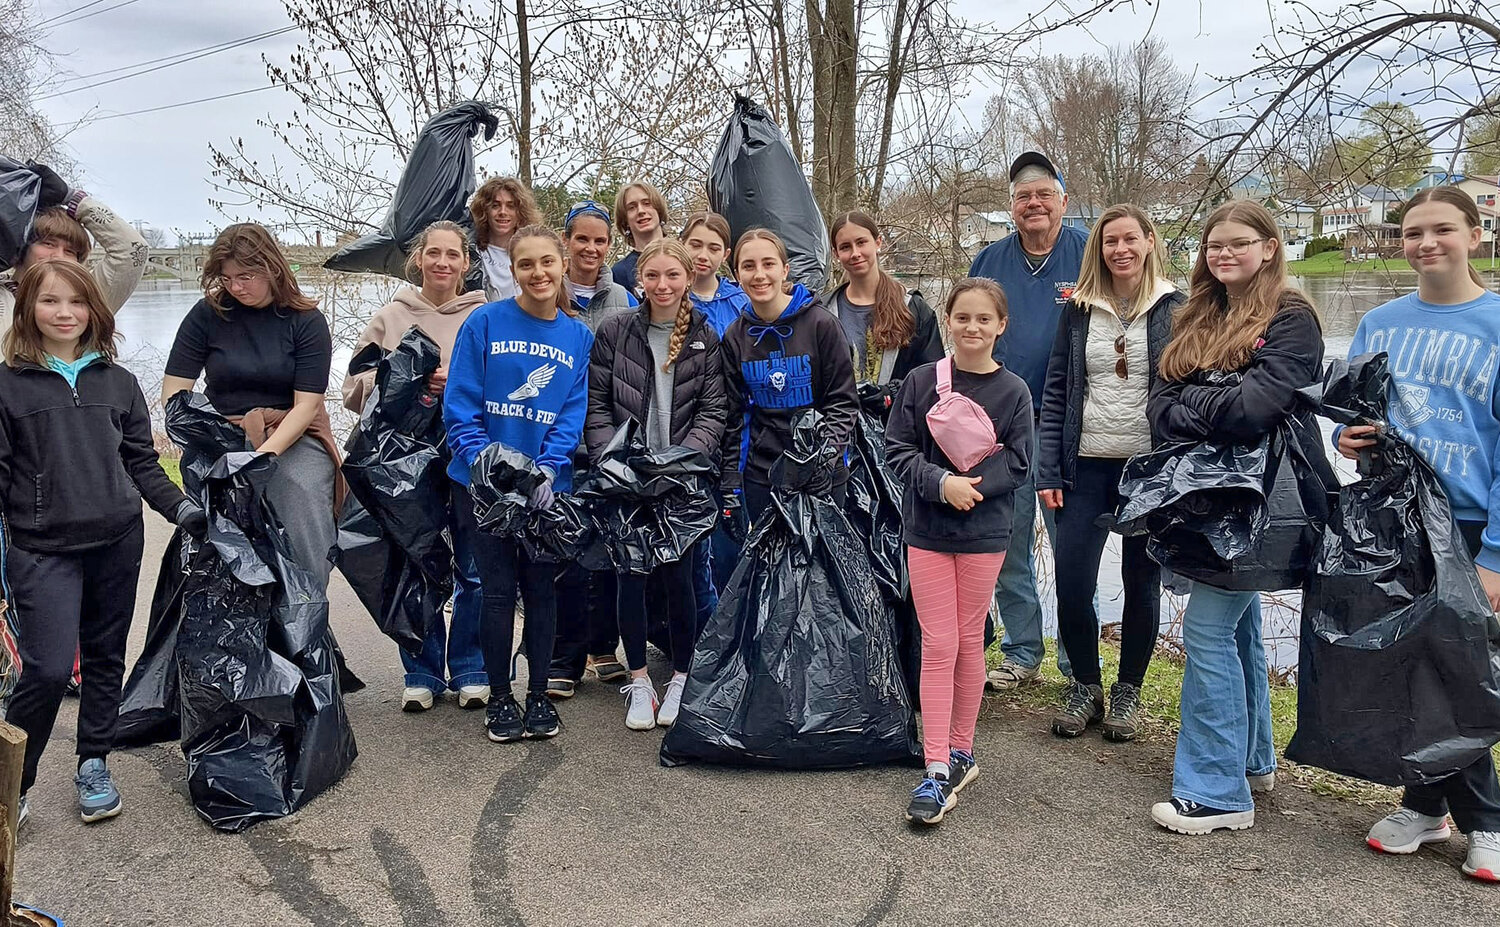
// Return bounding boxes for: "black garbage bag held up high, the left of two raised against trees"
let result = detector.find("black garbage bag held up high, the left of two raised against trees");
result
[323,101,500,281]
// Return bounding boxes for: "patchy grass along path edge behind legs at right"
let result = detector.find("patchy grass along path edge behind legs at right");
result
[987,629,1500,806]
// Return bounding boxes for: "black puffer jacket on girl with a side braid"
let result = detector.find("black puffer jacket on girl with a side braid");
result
[584,306,728,465]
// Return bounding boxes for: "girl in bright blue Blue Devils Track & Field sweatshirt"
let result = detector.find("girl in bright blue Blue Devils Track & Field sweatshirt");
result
[443,225,594,743]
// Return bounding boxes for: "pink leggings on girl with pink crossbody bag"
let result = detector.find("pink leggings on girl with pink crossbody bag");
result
[906,548,1005,764]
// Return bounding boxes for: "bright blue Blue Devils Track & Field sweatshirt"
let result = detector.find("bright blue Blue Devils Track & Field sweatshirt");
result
[443,299,594,492]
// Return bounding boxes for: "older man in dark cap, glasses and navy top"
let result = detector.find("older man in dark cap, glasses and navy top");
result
[969,152,1089,689]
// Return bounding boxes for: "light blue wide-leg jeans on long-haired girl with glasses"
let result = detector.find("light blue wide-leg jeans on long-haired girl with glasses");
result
[1172,582,1277,812]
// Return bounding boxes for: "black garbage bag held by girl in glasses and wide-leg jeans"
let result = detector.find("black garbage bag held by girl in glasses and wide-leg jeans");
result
[1115,417,1332,593]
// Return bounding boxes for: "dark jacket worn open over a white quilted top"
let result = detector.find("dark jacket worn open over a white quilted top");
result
[1037,282,1187,489]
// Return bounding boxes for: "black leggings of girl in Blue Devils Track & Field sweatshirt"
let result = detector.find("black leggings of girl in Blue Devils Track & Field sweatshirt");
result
[453,483,557,698]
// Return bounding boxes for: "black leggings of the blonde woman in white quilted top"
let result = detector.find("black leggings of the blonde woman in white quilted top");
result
[1053,458,1161,686]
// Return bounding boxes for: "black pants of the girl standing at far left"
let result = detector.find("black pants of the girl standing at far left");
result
[6,521,144,795]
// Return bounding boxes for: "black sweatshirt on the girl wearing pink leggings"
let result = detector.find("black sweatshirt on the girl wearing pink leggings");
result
[885,363,1032,554]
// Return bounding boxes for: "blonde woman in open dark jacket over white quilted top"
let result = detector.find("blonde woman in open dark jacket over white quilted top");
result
[1037,204,1184,741]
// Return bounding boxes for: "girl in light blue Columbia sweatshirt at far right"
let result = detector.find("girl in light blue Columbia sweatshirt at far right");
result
[1338,186,1500,882]
